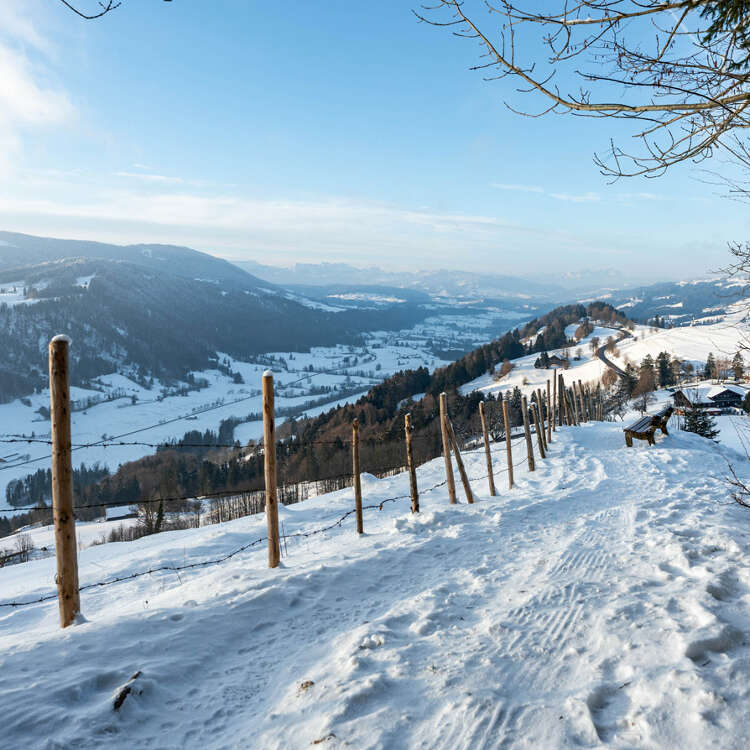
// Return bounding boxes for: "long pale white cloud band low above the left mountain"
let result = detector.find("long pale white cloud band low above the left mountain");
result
[0,187,579,268]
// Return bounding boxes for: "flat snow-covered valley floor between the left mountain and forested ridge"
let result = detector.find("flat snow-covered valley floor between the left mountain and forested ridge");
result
[0,310,521,509]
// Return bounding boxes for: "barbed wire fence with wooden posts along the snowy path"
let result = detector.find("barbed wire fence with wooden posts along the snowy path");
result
[0,337,604,627]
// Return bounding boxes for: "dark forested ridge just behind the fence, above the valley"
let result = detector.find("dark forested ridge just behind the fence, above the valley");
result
[0,303,628,532]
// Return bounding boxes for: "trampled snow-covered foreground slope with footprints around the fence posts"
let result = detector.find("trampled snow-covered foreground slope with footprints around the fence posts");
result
[0,424,750,750]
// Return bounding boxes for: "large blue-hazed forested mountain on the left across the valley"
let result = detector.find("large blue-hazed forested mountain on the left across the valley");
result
[0,232,427,401]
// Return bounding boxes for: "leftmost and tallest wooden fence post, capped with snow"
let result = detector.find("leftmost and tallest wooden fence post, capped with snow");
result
[49,336,81,628]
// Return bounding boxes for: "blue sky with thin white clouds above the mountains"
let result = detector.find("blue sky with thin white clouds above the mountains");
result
[0,0,750,280]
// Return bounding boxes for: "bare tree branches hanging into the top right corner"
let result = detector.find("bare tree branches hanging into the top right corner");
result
[415,0,750,177]
